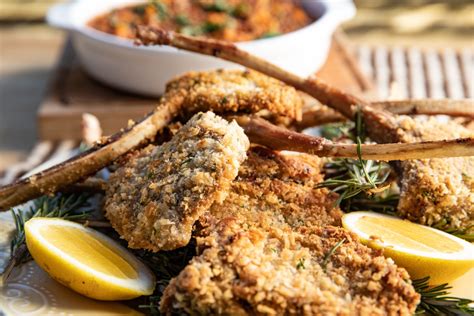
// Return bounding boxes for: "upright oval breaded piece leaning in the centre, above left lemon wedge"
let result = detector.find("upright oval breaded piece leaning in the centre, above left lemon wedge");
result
[105,112,249,251]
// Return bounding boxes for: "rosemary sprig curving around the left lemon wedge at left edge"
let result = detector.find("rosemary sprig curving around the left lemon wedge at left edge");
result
[2,193,91,282]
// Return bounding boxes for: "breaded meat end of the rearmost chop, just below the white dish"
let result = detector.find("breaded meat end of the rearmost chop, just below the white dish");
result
[166,70,303,120]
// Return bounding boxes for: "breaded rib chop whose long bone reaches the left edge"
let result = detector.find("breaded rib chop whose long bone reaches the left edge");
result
[0,71,301,210]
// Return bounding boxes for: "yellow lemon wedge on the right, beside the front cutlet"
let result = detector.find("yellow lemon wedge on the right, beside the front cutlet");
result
[342,212,474,285]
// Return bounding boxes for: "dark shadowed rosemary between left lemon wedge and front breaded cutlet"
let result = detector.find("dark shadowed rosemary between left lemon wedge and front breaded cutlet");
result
[134,239,196,315]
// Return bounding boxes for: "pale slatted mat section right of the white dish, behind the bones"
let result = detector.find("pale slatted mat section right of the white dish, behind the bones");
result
[356,46,474,99]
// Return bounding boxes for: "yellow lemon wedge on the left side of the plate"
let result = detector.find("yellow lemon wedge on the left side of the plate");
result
[25,218,155,301]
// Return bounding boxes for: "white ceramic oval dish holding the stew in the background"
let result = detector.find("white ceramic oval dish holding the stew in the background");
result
[47,0,355,96]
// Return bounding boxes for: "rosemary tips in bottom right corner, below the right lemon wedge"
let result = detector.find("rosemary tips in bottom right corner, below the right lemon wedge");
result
[412,277,474,316]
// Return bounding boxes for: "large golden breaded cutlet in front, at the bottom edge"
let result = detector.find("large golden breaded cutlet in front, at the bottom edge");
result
[160,217,419,315]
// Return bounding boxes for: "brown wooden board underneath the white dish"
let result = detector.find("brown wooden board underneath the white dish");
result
[38,33,374,141]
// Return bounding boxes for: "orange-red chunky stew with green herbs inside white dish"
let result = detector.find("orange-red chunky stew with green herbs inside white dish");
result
[89,0,312,42]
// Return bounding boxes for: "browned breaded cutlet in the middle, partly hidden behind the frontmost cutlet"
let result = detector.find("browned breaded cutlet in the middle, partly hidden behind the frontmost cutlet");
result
[206,146,343,229]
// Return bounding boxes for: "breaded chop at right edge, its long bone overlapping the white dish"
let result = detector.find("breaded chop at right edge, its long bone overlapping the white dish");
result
[138,27,474,231]
